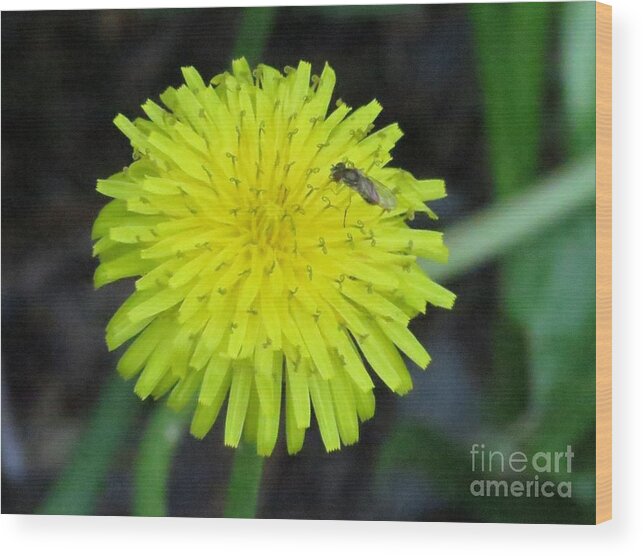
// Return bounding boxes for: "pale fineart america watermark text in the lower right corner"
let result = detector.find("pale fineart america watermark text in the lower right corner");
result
[469,444,574,498]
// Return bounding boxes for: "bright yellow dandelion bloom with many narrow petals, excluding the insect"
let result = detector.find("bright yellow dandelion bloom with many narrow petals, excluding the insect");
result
[92,59,455,455]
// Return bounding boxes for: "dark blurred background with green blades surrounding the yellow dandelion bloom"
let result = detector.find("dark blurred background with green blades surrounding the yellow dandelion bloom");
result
[2,2,595,523]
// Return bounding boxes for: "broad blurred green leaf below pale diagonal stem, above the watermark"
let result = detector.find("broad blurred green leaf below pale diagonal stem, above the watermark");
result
[505,207,596,449]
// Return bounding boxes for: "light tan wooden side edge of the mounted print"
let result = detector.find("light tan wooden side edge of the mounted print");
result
[596,2,612,523]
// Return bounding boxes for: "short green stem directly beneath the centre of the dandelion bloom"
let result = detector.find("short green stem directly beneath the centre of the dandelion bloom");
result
[223,445,263,519]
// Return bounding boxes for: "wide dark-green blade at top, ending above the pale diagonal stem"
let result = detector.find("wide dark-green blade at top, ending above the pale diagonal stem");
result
[470,3,551,197]
